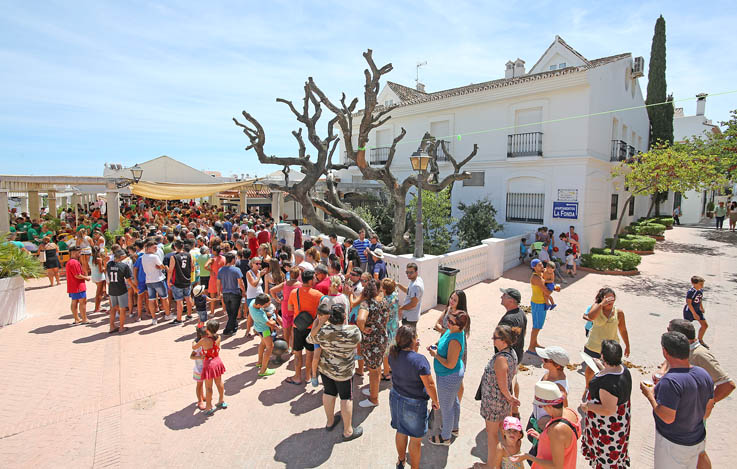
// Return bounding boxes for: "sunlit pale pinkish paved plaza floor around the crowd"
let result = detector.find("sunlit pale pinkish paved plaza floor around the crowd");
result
[0,222,737,468]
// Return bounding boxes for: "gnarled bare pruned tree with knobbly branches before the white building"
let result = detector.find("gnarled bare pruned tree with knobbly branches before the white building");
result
[233,49,478,253]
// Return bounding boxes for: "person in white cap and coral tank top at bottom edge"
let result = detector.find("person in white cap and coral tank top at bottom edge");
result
[510,381,581,469]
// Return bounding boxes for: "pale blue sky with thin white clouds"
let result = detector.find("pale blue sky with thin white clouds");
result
[0,0,737,176]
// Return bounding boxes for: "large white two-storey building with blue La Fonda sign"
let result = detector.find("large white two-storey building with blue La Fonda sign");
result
[341,36,649,254]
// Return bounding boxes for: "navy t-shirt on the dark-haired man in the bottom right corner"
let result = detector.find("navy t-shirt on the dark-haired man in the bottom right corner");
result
[653,366,714,446]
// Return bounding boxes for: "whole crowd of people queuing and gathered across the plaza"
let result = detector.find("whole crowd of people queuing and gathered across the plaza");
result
[2,195,735,468]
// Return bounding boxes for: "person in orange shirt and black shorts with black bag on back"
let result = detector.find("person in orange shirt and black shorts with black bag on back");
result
[286,270,323,384]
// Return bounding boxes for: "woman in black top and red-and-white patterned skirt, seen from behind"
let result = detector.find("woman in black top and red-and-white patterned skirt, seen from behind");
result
[581,340,632,468]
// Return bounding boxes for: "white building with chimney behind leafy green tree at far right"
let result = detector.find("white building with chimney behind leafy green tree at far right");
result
[660,93,720,224]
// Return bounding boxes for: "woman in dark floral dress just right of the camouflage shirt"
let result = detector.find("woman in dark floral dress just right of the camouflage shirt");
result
[356,279,390,407]
